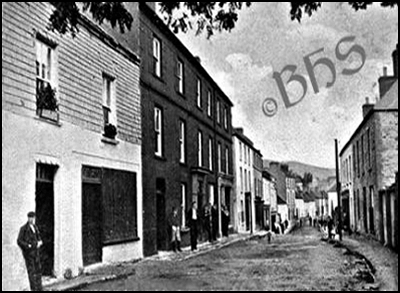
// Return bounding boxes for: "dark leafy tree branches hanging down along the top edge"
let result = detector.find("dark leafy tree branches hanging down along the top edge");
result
[49,2,397,37]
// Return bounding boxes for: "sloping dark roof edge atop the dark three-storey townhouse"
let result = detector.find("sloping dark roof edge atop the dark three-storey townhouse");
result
[139,2,235,107]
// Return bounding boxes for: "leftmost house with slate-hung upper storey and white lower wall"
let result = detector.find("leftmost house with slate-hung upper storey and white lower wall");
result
[2,2,143,290]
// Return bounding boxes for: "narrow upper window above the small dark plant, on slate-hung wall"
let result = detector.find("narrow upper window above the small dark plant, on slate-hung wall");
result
[103,74,117,126]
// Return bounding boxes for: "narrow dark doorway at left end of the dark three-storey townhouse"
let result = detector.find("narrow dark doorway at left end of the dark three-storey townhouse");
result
[156,178,168,250]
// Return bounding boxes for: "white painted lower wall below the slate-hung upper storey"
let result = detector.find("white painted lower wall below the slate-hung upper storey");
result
[2,110,143,290]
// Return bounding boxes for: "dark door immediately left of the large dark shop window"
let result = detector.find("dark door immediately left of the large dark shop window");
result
[82,167,103,266]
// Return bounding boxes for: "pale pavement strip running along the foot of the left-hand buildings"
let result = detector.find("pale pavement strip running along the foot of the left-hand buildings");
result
[43,231,267,291]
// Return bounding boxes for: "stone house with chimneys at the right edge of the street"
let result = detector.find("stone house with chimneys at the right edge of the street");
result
[342,44,399,246]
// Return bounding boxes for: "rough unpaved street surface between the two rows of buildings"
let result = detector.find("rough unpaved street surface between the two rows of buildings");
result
[76,227,378,291]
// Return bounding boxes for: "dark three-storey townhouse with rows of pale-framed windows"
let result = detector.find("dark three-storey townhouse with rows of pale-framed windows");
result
[104,2,234,256]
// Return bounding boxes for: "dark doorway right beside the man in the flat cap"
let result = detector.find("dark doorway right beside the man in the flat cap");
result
[36,164,57,276]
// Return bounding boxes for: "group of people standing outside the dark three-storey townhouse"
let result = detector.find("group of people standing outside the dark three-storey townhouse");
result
[169,202,230,252]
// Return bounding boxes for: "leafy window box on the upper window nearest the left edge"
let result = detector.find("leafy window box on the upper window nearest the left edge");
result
[36,85,59,123]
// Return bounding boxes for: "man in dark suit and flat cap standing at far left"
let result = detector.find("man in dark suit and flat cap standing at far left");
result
[18,212,43,291]
